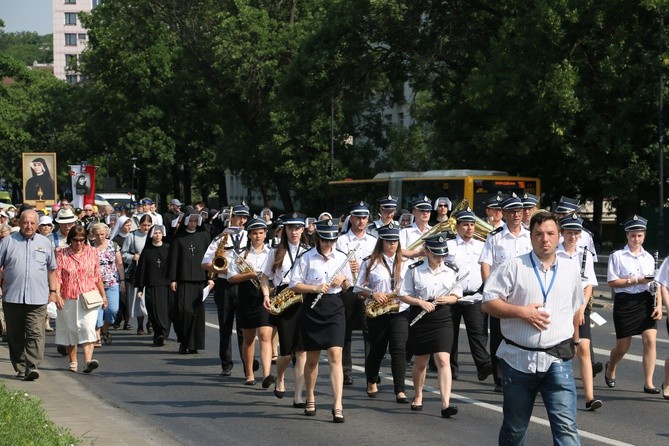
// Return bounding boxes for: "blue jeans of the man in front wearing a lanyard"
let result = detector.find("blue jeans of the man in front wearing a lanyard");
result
[499,360,581,445]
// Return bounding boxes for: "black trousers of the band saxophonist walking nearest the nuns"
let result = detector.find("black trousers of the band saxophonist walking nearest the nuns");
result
[214,278,244,369]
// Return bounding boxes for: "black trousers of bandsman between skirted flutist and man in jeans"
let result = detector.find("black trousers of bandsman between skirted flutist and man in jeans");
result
[451,301,490,373]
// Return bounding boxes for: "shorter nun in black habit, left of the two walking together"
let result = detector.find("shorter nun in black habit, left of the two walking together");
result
[135,225,176,347]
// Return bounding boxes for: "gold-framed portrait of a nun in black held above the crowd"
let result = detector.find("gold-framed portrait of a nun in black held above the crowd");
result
[22,153,58,205]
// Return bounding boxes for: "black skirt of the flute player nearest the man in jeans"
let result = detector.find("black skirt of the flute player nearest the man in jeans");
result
[409,305,454,356]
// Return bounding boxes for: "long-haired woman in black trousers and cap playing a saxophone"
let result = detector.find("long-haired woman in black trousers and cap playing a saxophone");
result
[356,223,409,404]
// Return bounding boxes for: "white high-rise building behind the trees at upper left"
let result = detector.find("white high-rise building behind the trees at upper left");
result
[51,0,102,83]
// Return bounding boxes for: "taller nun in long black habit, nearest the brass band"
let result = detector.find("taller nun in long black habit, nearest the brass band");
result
[169,214,211,354]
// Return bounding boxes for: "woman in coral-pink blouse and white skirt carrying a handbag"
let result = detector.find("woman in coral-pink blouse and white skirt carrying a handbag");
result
[56,225,107,373]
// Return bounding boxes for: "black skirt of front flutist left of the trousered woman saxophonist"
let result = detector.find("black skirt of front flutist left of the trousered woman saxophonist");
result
[300,294,346,351]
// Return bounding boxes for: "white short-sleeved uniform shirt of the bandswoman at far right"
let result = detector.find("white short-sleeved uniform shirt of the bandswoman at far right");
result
[606,245,655,294]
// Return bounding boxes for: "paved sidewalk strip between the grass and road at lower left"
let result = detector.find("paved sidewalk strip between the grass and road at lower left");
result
[0,343,180,446]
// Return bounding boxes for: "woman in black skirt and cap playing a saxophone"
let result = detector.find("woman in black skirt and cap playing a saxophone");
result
[260,213,310,408]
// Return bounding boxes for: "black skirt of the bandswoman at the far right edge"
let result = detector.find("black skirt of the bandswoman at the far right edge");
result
[613,291,657,339]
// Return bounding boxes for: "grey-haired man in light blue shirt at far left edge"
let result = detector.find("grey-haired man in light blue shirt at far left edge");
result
[0,210,56,381]
